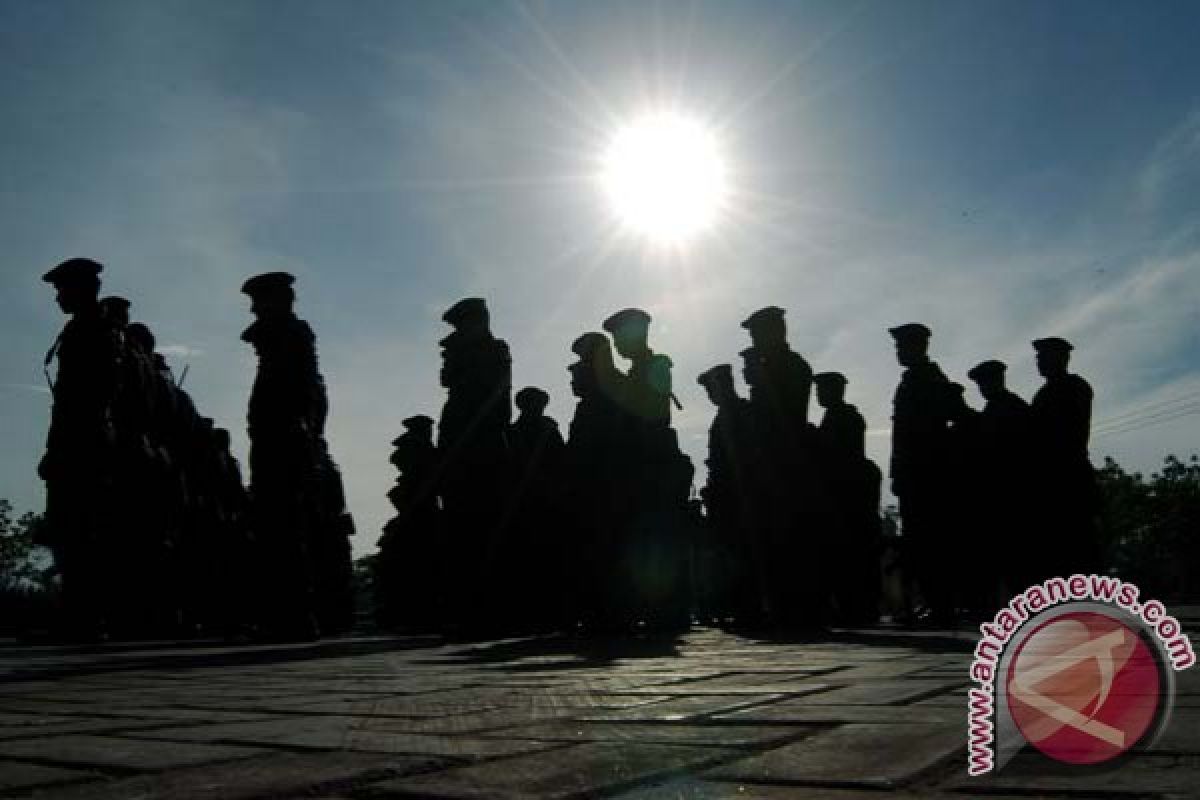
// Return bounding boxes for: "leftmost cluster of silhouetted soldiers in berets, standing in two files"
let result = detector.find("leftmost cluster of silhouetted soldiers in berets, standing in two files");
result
[38,258,353,640]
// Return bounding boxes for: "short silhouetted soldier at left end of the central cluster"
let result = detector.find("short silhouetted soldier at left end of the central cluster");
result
[376,414,450,631]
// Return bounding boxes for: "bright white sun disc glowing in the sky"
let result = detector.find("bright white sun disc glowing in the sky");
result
[601,113,726,245]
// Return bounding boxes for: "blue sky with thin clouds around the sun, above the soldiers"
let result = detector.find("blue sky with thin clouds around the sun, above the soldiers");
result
[0,0,1200,553]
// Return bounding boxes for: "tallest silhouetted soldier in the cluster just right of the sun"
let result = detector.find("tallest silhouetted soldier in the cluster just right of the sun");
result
[742,306,828,627]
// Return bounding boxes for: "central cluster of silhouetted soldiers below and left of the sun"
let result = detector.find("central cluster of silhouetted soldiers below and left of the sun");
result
[377,297,692,631]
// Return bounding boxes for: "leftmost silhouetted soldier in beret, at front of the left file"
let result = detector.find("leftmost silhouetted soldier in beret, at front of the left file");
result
[37,258,119,639]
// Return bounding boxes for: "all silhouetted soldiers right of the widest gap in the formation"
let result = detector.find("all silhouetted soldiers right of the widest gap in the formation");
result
[377,303,1099,631]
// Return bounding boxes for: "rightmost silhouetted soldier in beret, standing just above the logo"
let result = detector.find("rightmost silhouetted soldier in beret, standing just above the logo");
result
[1030,336,1100,581]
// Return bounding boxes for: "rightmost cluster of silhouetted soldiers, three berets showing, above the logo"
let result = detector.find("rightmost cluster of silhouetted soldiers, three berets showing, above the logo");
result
[890,323,1102,624]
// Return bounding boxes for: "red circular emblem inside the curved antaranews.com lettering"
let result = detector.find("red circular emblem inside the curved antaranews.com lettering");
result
[1006,612,1162,764]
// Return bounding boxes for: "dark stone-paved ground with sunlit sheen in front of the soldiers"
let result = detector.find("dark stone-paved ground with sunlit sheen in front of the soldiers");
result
[0,624,1200,800]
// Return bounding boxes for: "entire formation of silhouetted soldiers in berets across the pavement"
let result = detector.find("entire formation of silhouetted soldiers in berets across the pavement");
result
[40,259,1099,640]
